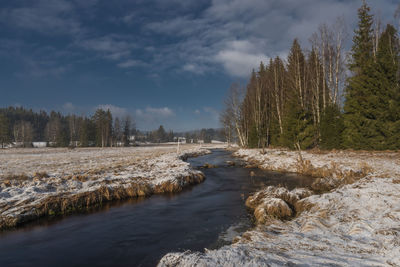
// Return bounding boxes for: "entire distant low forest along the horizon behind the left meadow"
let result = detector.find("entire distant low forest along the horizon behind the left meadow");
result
[0,107,224,148]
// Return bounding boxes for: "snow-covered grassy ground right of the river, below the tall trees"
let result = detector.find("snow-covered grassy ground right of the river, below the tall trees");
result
[160,149,400,266]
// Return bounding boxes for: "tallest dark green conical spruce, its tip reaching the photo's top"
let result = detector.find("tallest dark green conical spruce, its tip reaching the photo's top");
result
[343,1,381,149]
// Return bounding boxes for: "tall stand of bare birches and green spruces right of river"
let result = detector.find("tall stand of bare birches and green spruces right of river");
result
[220,1,400,150]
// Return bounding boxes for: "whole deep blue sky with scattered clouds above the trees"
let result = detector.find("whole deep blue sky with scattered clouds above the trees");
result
[0,0,399,131]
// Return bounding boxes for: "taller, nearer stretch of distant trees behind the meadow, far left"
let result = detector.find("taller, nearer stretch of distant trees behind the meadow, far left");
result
[0,107,136,147]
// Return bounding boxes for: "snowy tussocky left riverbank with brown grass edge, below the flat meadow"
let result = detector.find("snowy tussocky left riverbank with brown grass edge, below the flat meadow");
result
[0,148,210,230]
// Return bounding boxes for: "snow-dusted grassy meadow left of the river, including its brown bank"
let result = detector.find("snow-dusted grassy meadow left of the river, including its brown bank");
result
[0,145,222,228]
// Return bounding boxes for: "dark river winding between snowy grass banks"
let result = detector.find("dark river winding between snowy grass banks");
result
[0,150,312,266]
